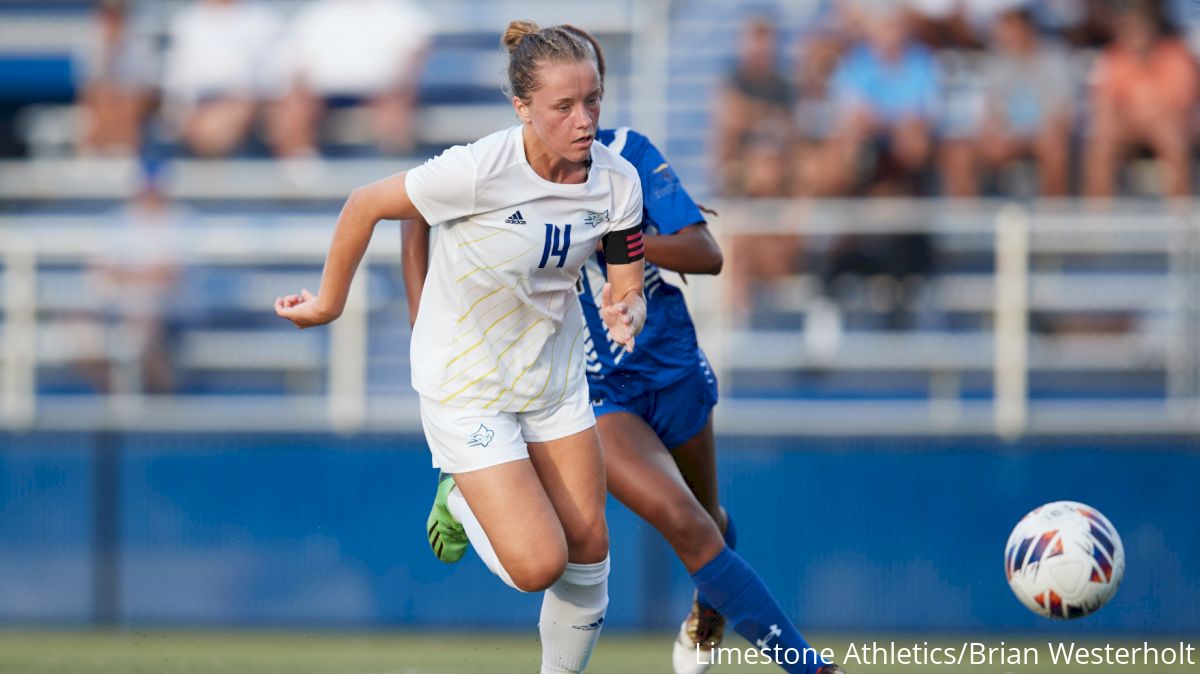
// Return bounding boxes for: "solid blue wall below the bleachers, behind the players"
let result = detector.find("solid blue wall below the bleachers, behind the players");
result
[0,433,1200,634]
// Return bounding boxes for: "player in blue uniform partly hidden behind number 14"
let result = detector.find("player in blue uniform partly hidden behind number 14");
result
[403,26,841,674]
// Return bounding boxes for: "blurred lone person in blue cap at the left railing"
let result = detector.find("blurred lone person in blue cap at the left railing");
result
[79,167,182,393]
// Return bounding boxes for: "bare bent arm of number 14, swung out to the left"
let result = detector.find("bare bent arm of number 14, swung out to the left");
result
[275,173,420,327]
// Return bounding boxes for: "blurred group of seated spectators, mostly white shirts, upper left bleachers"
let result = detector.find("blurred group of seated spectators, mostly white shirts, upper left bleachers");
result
[10,0,432,157]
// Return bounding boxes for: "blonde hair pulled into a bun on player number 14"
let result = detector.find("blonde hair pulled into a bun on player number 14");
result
[500,19,596,102]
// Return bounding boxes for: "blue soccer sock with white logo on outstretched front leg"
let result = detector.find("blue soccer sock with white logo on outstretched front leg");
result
[691,547,828,674]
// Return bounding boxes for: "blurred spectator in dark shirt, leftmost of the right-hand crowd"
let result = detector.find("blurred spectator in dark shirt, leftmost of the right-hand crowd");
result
[714,17,792,197]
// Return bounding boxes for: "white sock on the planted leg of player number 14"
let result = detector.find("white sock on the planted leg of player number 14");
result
[538,558,608,674]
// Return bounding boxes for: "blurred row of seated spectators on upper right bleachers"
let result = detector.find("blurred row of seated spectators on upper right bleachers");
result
[714,0,1200,197]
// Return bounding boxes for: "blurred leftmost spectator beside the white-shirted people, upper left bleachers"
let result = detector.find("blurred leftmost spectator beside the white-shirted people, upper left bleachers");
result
[79,0,157,155]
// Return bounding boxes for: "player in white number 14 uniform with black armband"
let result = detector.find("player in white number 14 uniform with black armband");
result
[275,22,646,672]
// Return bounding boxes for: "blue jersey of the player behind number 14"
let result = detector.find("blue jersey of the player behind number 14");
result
[580,127,704,402]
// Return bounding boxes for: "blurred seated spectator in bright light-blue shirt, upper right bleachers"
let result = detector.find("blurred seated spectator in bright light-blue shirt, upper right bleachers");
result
[808,0,941,331]
